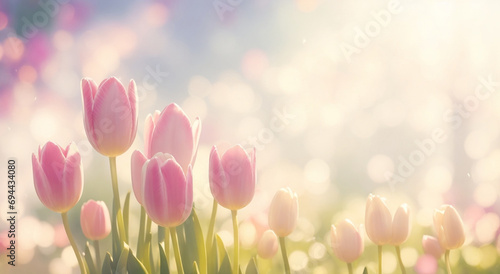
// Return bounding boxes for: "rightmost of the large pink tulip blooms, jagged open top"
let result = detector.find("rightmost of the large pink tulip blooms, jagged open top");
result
[209,145,255,210]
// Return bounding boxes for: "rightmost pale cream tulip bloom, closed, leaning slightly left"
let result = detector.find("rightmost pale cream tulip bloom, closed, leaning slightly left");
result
[434,205,465,250]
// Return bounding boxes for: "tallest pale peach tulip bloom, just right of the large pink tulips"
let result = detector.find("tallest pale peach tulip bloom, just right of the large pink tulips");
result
[269,187,299,237]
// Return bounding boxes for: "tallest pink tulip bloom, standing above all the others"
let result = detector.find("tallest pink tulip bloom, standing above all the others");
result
[82,77,138,157]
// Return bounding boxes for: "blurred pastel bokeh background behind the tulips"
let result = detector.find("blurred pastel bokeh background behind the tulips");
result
[0,0,500,274]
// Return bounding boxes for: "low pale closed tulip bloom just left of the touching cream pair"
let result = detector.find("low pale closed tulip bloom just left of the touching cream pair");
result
[331,219,364,263]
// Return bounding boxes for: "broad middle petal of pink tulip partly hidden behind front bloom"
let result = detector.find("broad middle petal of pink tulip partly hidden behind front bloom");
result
[150,104,193,172]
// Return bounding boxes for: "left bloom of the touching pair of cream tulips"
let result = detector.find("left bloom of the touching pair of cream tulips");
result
[365,194,392,245]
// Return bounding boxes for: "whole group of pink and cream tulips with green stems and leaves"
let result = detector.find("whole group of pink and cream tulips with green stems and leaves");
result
[32,77,465,274]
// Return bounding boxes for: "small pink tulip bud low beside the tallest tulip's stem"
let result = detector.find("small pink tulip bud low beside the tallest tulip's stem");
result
[80,200,111,241]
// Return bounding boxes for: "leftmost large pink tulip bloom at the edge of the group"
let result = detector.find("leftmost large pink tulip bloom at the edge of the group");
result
[32,142,83,213]
